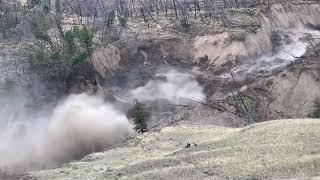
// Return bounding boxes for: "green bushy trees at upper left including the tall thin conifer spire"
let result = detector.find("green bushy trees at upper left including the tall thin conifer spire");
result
[29,0,93,81]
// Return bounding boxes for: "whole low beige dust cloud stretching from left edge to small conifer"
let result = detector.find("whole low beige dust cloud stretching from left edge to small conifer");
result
[0,94,133,174]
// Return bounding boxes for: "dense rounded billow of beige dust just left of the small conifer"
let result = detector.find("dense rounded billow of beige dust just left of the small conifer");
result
[39,94,132,165]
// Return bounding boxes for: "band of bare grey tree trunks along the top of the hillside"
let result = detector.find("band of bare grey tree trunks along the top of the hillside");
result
[0,0,271,42]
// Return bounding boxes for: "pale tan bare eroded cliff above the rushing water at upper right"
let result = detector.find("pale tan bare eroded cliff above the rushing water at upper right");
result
[194,1,320,66]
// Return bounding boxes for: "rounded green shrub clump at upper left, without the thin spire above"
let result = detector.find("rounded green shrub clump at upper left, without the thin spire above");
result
[28,25,93,81]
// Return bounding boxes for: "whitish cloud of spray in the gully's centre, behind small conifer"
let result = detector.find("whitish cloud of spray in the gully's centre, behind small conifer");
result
[130,70,205,103]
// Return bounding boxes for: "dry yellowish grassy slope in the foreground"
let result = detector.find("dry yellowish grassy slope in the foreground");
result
[25,119,320,180]
